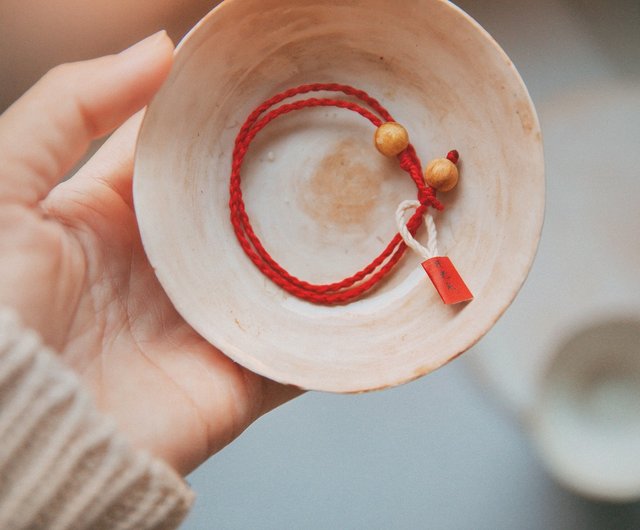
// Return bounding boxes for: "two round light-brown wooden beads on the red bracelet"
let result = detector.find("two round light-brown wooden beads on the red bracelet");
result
[374,121,459,191]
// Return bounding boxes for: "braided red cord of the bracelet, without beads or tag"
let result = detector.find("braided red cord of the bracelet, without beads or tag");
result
[229,83,444,305]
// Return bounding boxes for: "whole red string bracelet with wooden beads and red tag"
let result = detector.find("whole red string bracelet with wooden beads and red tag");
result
[229,83,472,305]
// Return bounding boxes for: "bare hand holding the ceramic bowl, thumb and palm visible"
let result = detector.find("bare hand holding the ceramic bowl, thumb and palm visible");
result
[0,32,299,473]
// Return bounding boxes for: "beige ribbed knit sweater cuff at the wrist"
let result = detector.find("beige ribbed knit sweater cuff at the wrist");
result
[0,308,193,530]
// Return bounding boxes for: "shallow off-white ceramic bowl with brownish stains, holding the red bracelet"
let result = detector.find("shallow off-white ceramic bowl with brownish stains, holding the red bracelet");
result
[134,0,544,392]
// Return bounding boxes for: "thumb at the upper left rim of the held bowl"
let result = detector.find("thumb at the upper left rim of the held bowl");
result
[0,32,173,204]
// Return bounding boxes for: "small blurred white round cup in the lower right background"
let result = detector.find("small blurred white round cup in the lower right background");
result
[530,320,640,501]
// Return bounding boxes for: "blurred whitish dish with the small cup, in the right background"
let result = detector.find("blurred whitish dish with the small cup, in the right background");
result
[474,84,640,501]
